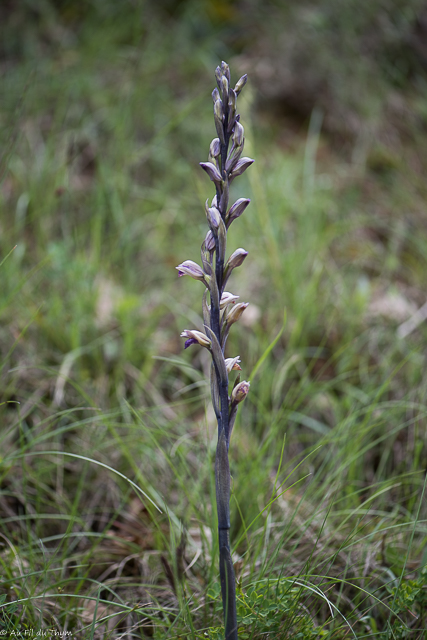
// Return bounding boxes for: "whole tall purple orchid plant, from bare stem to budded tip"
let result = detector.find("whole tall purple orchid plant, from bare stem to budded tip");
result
[176,62,254,640]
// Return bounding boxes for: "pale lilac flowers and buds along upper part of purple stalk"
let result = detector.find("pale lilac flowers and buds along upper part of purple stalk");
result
[176,62,254,444]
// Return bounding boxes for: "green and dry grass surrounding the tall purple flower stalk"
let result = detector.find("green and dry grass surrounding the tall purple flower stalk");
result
[0,2,427,640]
